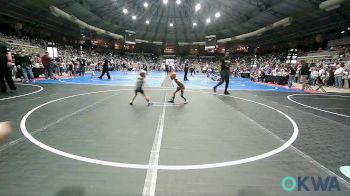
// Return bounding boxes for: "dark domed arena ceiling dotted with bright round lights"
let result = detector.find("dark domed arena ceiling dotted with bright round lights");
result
[0,0,350,43]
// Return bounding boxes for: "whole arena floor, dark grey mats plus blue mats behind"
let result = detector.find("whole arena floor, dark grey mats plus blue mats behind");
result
[0,72,350,196]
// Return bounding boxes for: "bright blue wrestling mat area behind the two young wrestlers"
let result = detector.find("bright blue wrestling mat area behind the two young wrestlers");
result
[36,71,302,92]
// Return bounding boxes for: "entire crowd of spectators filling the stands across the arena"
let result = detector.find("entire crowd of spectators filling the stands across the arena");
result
[0,30,350,88]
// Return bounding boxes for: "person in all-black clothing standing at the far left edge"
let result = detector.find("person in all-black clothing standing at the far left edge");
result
[0,42,16,93]
